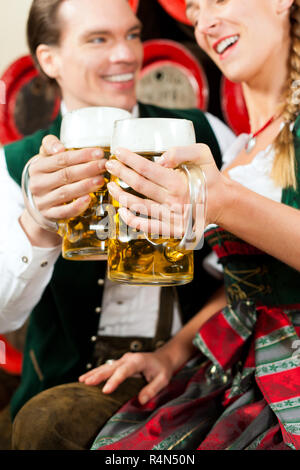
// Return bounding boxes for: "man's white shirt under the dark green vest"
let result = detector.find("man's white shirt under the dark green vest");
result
[0,113,234,337]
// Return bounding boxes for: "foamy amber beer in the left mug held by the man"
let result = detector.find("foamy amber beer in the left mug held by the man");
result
[58,107,131,261]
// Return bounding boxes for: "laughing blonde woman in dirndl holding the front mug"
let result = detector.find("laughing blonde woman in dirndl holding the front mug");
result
[80,0,300,450]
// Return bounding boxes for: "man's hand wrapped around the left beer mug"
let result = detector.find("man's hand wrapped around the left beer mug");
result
[20,135,106,246]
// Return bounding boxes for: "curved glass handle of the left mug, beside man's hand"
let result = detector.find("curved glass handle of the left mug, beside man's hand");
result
[22,159,59,233]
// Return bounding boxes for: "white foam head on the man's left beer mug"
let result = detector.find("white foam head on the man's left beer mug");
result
[60,106,131,149]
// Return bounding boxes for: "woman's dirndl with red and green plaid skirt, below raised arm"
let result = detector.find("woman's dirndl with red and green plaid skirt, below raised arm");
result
[92,226,300,450]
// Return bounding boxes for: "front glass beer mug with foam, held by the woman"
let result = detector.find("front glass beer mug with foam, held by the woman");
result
[108,118,206,286]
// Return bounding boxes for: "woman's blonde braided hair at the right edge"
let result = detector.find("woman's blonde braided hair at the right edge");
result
[272,0,300,189]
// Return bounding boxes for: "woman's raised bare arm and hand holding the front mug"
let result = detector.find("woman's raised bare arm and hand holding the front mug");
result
[107,144,300,270]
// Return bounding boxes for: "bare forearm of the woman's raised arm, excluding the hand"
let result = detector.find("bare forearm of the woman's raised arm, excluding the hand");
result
[215,176,300,271]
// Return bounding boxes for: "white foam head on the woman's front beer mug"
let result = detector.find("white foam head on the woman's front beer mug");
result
[111,118,196,153]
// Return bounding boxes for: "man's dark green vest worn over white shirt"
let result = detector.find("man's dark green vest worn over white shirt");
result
[5,104,221,417]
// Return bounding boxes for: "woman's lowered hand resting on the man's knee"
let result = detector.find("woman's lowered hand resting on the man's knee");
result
[79,349,174,404]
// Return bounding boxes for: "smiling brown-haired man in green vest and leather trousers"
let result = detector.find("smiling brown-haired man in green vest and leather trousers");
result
[0,0,232,449]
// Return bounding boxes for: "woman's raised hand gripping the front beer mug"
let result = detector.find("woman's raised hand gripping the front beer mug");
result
[106,144,226,238]
